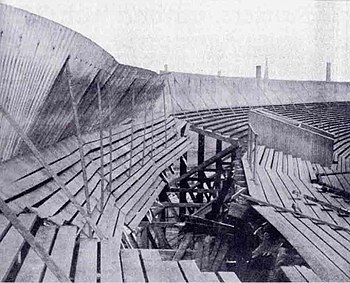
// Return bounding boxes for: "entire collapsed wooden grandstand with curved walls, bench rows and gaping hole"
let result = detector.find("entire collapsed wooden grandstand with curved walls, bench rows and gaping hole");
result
[0,2,350,282]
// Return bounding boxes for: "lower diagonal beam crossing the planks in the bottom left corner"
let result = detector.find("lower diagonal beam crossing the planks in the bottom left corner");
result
[0,197,71,282]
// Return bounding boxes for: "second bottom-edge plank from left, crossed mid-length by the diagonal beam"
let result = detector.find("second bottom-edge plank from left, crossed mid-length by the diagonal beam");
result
[16,226,56,282]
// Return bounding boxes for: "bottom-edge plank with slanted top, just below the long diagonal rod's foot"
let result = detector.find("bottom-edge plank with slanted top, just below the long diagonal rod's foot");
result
[101,239,123,282]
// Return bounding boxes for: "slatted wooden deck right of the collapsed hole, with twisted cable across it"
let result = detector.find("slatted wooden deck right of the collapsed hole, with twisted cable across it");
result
[242,146,350,281]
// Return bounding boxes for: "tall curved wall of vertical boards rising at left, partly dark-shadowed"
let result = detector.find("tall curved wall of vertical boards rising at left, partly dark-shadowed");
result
[0,4,162,160]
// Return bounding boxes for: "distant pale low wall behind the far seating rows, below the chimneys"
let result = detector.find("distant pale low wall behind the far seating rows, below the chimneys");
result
[161,72,350,112]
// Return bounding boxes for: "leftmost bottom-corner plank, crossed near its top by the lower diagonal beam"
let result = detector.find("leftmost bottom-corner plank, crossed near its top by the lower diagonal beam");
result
[0,214,36,282]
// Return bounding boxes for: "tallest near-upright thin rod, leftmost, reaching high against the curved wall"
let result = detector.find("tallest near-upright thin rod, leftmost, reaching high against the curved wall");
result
[66,61,92,238]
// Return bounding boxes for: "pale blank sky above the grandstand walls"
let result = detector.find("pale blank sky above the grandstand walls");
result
[0,0,350,81]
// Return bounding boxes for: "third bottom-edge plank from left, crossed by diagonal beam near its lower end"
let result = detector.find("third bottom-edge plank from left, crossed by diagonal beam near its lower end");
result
[43,226,77,282]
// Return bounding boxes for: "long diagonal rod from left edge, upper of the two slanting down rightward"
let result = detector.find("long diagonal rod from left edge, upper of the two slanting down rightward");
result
[0,102,104,239]
